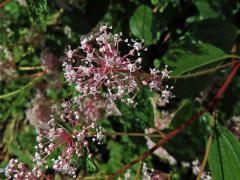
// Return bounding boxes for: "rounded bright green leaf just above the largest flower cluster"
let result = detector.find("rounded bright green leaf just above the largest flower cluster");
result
[129,5,153,45]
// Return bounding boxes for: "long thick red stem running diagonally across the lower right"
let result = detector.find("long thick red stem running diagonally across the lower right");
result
[108,63,240,179]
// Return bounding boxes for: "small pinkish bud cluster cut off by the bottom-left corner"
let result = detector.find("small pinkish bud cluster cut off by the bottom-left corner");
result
[0,159,37,180]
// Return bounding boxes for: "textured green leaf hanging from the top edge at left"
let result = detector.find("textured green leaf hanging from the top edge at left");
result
[27,0,47,31]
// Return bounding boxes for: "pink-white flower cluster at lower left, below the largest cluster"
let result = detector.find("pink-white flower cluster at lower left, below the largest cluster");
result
[33,102,104,177]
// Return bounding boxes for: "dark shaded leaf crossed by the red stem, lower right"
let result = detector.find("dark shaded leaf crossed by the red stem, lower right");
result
[164,99,212,161]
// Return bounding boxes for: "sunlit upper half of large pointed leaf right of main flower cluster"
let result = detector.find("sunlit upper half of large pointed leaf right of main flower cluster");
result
[163,43,231,76]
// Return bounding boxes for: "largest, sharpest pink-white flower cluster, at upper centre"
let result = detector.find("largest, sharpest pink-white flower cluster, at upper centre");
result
[63,26,172,104]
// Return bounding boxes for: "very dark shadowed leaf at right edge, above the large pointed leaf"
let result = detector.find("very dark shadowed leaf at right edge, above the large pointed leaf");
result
[193,19,239,52]
